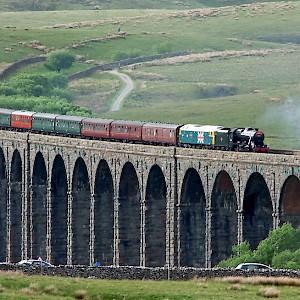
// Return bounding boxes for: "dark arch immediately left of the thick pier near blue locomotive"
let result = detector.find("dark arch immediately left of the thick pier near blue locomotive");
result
[145,164,167,267]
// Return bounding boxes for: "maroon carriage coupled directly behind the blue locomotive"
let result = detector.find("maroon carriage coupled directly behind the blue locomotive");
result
[142,123,182,145]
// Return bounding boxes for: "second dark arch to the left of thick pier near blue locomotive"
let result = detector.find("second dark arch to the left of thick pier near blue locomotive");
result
[119,162,141,266]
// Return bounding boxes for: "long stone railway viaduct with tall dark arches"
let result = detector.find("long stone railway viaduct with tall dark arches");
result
[0,130,300,267]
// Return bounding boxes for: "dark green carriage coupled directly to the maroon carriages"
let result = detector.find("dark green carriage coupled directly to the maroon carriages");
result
[55,115,84,136]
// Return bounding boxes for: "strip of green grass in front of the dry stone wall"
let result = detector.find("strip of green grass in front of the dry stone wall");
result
[0,272,300,300]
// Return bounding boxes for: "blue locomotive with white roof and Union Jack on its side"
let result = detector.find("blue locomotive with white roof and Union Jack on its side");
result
[179,124,223,148]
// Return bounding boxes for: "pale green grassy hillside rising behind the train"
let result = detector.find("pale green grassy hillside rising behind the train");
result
[0,1,300,149]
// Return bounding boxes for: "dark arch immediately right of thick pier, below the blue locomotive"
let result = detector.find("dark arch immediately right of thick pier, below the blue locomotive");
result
[179,168,206,267]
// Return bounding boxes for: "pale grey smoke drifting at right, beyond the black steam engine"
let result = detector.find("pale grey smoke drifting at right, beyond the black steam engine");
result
[258,97,300,149]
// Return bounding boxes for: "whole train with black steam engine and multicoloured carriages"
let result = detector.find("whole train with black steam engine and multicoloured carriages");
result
[0,108,268,152]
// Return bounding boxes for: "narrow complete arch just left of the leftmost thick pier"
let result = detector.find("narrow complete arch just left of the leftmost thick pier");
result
[10,150,23,262]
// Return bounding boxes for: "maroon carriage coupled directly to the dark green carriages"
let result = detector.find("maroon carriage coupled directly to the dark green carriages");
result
[81,118,113,139]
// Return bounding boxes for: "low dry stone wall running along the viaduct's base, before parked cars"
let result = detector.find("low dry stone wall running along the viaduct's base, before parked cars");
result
[0,264,300,280]
